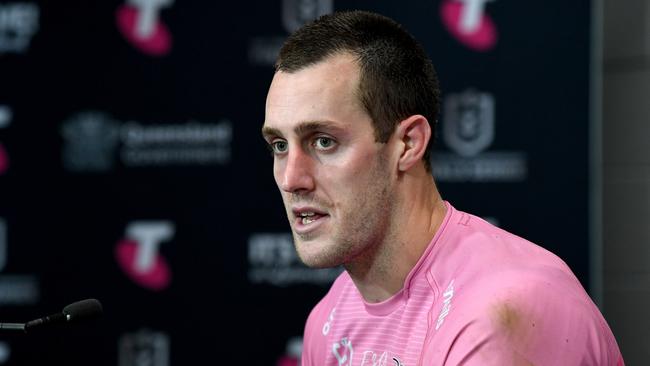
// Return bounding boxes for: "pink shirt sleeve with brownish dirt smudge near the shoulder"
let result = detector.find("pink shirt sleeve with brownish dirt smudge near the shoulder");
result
[436,280,623,366]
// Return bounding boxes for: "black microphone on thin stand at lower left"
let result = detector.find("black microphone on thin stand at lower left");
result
[0,299,103,332]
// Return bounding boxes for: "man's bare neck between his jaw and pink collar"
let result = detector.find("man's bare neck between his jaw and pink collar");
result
[344,174,447,303]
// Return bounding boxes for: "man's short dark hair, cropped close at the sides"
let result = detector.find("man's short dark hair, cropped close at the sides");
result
[275,10,440,171]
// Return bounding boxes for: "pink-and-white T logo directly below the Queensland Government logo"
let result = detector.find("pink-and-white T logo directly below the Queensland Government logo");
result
[115,221,175,291]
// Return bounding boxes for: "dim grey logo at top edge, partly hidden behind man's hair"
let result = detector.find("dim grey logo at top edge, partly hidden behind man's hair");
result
[248,0,334,66]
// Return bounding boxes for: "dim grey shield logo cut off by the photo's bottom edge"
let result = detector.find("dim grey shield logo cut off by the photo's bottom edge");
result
[118,329,170,366]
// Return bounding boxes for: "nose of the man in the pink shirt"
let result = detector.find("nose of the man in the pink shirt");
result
[278,149,314,193]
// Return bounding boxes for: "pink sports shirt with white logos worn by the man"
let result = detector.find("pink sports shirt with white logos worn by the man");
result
[302,203,624,366]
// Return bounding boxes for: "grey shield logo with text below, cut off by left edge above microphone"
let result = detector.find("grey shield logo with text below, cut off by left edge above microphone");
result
[0,217,40,306]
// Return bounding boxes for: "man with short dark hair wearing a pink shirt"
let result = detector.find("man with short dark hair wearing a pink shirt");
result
[262,11,623,366]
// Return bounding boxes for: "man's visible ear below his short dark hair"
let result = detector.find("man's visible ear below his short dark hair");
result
[396,114,431,172]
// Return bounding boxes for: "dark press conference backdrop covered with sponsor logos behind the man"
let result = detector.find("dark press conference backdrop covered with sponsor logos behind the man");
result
[0,0,591,366]
